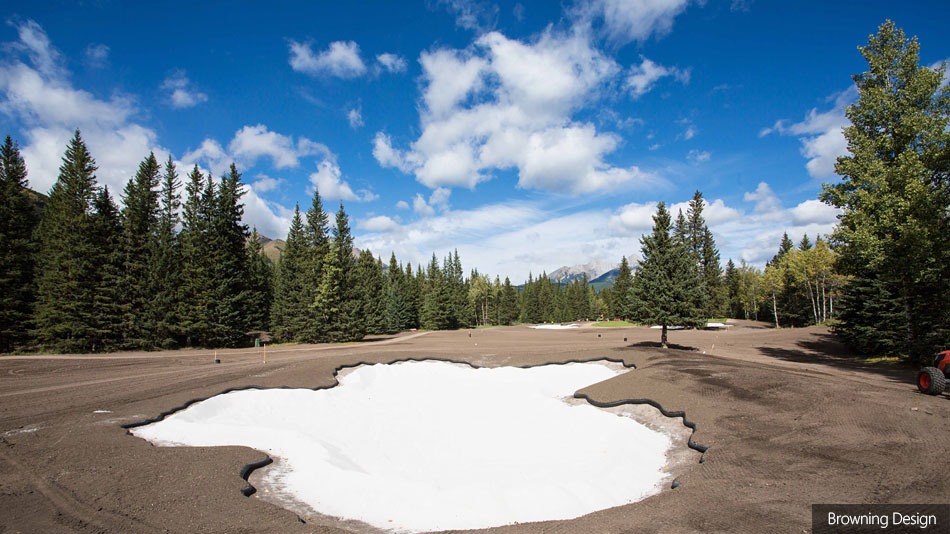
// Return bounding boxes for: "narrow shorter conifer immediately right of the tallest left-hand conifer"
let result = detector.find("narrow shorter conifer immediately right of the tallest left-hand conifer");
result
[91,187,123,352]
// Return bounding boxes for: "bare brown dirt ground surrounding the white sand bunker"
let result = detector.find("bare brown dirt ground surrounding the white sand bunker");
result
[0,322,950,534]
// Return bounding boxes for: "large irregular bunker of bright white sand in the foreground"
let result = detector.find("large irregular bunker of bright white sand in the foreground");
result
[132,361,671,532]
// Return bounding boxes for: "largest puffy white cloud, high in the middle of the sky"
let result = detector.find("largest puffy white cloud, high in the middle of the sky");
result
[373,29,660,194]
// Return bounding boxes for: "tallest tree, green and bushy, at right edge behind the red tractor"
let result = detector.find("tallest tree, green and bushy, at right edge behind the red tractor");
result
[821,20,950,359]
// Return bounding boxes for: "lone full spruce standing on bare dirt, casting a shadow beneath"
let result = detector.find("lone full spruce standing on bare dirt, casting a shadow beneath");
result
[634,202,705,348]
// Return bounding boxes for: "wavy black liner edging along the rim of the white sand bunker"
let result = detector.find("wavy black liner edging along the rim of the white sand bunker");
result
[121,357,709,504]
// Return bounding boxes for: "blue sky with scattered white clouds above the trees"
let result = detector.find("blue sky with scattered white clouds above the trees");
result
[0,0,950,282]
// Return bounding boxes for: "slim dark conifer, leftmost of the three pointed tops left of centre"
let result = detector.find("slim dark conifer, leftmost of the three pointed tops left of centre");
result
[271,206,308,343]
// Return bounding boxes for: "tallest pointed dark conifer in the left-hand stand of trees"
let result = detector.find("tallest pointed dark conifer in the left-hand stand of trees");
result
[34,130,99,352]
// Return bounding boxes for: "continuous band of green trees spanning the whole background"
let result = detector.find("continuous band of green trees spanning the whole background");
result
[0,21,950,359]
